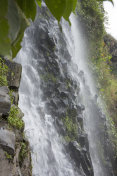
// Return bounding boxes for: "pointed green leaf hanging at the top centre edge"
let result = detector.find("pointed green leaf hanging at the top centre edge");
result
[45,0,67,21]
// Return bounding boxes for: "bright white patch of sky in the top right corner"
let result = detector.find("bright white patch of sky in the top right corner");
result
[104,0,117,39]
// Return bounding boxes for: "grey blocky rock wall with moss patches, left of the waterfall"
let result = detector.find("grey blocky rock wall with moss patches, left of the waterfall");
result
[0,59,31,176]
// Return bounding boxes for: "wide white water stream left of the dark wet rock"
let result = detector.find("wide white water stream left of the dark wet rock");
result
[16,15,80,176]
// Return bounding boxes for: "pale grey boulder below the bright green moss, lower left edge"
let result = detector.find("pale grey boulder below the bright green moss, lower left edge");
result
[0,127,15,155]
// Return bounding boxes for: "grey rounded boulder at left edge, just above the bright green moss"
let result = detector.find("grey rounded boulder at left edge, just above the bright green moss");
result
[0,86,11,115]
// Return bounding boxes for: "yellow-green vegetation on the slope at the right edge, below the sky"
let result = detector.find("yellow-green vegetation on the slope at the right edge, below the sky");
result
[92,43,117,124]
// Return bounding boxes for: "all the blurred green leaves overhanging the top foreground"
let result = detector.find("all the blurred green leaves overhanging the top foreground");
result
[0,0,112,58]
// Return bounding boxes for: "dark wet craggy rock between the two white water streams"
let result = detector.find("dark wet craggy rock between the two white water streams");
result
[27,8,93,176]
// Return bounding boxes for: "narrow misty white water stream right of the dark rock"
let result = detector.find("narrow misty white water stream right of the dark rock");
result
[63,14,107,176]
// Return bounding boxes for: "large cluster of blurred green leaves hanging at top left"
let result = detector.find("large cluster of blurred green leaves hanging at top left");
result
[0,0,36,58]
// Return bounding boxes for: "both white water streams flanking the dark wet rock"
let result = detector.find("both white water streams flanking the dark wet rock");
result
[17,8,109,176]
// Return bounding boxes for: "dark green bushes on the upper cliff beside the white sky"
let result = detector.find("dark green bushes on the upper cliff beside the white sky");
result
[77,0,104,48]
